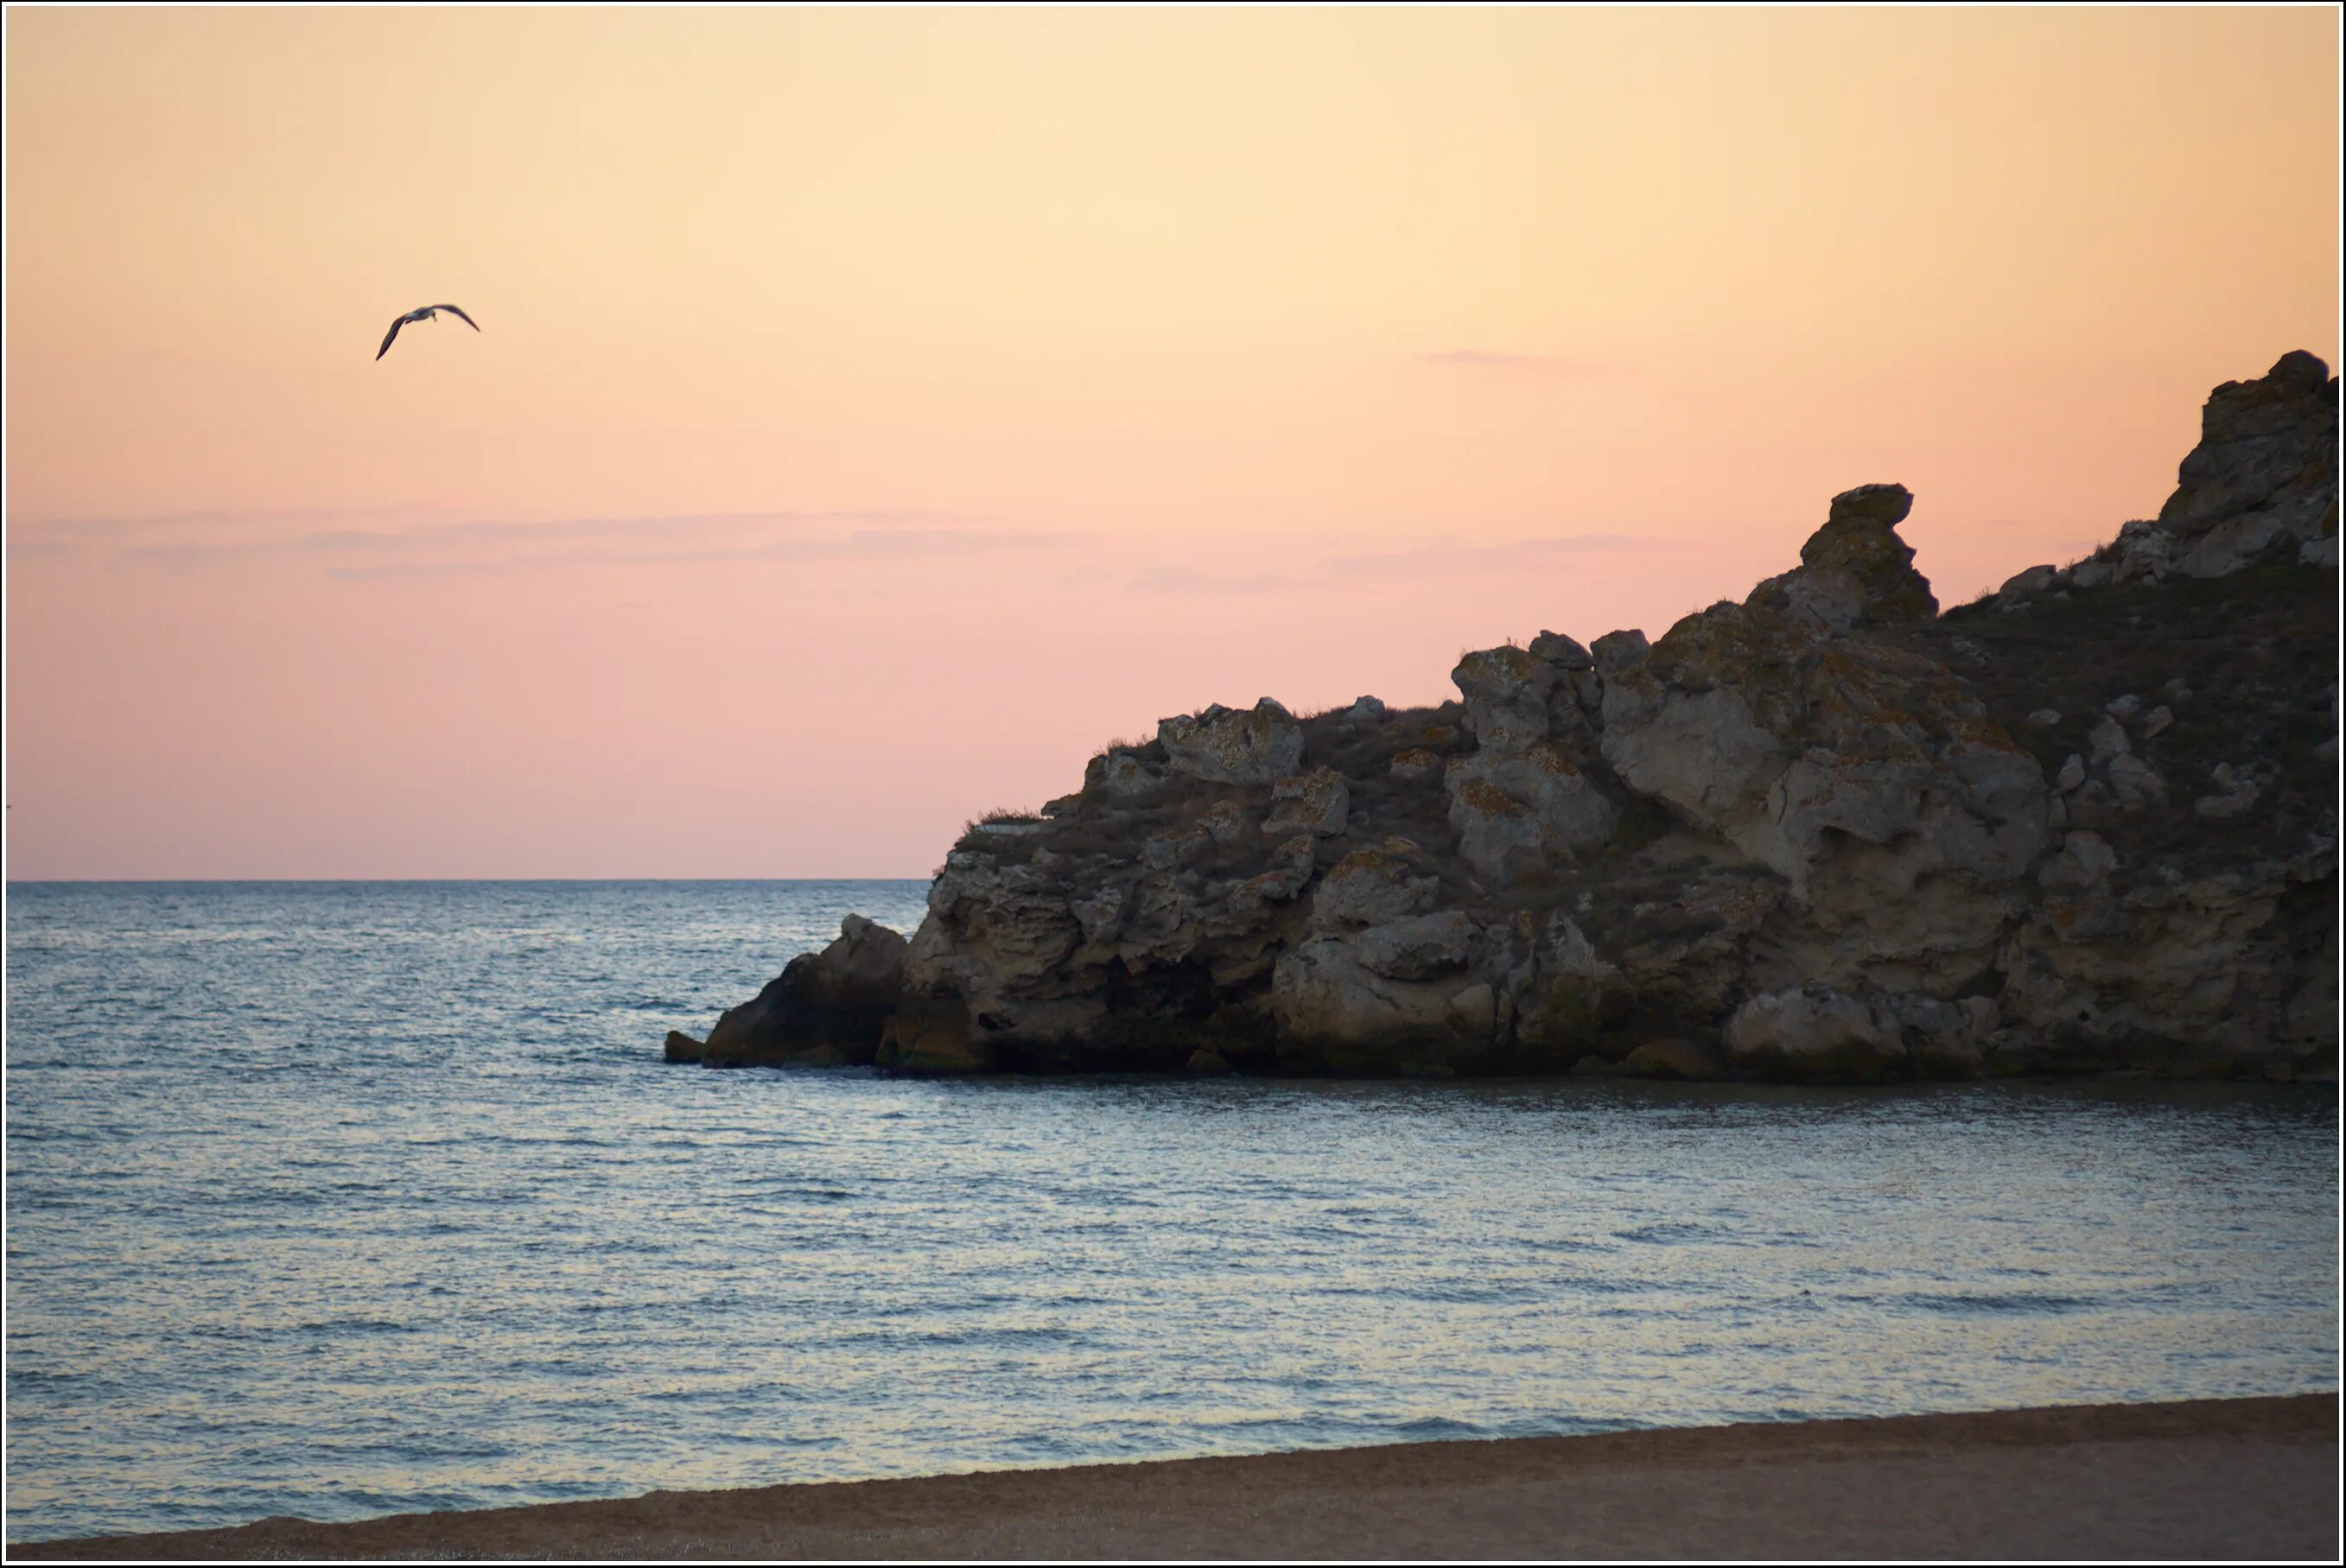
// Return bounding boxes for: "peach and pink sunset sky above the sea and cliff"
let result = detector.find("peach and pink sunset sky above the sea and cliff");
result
[4,7,2339,879]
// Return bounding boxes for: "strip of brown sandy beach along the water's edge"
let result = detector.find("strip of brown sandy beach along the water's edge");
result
[10,1394,2339,1561]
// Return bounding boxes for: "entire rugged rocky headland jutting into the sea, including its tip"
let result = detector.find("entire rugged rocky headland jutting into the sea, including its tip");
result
[669,354,2339,1082]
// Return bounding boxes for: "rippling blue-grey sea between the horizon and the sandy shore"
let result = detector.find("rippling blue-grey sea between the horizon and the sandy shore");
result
[7,881,2339,1539]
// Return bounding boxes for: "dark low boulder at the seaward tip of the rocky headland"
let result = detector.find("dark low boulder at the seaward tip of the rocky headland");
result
[694,914,908,1066]
